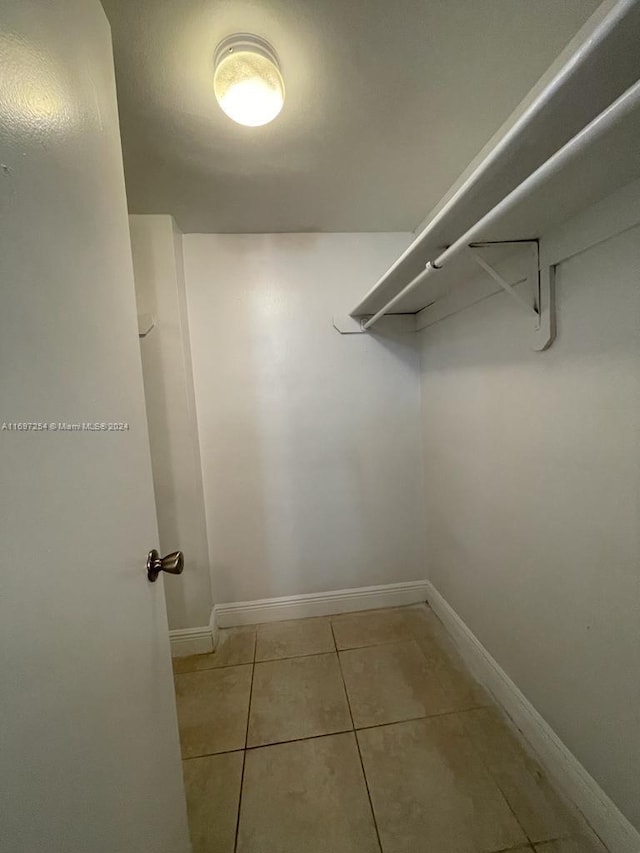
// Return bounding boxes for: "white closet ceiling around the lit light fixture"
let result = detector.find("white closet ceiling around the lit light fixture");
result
[102,0,598,232]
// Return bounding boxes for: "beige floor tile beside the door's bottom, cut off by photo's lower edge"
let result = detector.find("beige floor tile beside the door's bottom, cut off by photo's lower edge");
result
[183,752,243,853]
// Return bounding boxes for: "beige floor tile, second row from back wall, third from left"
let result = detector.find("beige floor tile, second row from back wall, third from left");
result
[340,640,455,728]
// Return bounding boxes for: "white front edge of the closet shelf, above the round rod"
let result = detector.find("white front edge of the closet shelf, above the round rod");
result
[351,0,638,317]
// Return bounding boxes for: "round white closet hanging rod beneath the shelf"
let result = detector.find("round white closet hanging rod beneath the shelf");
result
[362,80,640,329]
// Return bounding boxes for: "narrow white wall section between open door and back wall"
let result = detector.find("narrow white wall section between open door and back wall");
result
[129,216,212,629]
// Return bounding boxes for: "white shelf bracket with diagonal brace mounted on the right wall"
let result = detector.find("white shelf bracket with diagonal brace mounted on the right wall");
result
[469,240,555,352]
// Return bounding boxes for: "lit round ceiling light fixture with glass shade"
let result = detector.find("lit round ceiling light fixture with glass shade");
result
[213,33,284,127]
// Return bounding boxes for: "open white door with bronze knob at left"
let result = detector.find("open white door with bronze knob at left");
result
[0,0,190,853]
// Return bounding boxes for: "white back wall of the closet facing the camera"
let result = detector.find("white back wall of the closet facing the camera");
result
[183,234,424,602]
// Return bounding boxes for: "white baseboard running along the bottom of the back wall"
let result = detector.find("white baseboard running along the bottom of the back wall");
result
[214,581,428,628]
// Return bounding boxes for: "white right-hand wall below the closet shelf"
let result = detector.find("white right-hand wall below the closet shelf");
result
[422,216,640,828]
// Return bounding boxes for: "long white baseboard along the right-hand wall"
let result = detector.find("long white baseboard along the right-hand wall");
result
[425,581,640,853]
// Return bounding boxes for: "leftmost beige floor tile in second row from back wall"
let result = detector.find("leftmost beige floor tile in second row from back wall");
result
[175,664,253,758]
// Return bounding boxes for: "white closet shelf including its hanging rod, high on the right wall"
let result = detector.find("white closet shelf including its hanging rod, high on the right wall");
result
[350,0,640,329]
